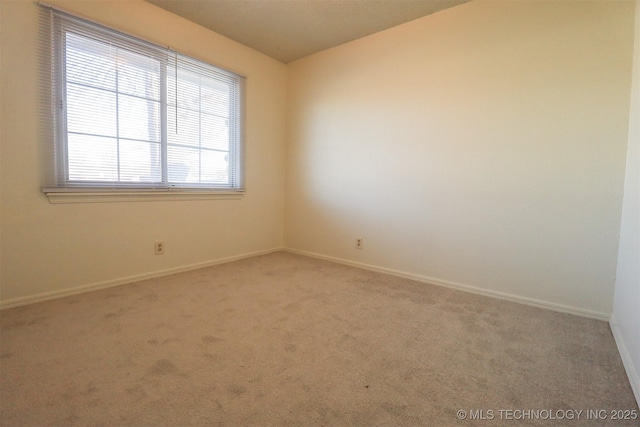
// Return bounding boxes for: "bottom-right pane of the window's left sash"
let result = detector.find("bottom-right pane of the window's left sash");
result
[120,140,162,182]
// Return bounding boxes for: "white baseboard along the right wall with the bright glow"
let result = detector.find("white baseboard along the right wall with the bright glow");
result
[284,248,611,321]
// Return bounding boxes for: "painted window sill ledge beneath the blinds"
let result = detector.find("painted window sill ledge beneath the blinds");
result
[42,188,244,204]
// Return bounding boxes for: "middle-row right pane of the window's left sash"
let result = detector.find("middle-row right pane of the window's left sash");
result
[118,95,160,142]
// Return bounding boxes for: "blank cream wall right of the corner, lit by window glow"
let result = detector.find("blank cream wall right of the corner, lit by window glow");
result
[285,1,634,317]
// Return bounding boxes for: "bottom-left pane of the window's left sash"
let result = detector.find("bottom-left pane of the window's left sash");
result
[67,134,118,181]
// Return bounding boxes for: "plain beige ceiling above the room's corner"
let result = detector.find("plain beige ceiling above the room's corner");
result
[147,0,469,63]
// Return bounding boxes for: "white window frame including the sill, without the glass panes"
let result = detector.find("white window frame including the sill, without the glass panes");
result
[43,9,245,203]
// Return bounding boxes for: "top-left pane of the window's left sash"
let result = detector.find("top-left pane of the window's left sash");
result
[66,32,116,90]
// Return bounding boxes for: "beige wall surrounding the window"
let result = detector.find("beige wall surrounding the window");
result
[0,0,286,304]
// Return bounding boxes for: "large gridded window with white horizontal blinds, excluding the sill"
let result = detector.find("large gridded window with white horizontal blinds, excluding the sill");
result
[45,10,244,197]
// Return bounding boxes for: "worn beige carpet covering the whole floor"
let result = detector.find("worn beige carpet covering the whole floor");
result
[0,252,640,426]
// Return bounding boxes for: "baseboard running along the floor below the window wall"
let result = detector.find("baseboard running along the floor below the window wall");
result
[0,248,282,310]
